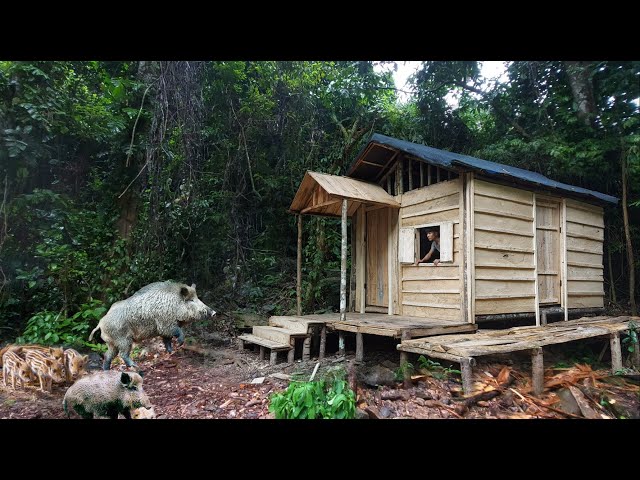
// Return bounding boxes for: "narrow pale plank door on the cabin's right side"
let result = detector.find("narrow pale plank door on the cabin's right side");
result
[536,195,561,305]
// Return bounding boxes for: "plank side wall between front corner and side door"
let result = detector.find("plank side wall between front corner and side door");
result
[472,179,537,315]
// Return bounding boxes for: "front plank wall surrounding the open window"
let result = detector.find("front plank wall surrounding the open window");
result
[394,178,463,320]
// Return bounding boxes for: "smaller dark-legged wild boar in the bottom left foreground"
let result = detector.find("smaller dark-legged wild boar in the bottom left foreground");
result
[62,371,152,419]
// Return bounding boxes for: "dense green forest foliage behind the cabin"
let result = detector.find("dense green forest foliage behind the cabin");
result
[0,61,640,341]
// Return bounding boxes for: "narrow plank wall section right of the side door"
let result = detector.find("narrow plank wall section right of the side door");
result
[566,199,604,308]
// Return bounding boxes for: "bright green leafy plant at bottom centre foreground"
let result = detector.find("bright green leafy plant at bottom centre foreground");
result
[269,379,356,419]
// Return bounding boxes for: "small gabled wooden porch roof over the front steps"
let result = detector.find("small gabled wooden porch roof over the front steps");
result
[289,171,400,217]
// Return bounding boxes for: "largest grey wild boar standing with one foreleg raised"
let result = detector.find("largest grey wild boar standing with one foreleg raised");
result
[89,281,216,370]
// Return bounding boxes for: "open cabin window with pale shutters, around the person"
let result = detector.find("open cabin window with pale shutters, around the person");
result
[398,222,453,264]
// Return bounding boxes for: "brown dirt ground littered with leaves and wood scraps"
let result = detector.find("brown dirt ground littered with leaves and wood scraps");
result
[0,335,640,419]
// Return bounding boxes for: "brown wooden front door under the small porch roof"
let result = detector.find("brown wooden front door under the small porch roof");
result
[365,208,389,308]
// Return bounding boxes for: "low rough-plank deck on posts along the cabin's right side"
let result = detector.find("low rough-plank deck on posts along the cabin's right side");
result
[397,316,640,394]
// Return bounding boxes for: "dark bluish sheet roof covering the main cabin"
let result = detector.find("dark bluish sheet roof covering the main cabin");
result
[347,133,618,203]
